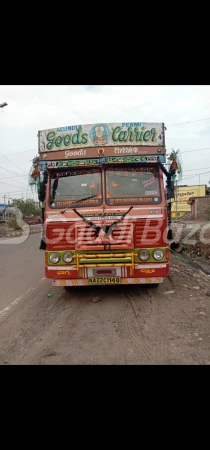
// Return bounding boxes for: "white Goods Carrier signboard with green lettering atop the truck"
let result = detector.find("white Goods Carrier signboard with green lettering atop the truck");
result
[38,122,164,153]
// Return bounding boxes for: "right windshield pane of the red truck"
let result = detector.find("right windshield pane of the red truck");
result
[105,165,161,205]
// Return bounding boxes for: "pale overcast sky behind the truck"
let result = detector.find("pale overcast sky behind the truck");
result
[0,85,210,203]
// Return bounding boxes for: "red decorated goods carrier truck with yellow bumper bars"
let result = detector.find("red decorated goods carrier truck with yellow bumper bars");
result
[31,122,175,287]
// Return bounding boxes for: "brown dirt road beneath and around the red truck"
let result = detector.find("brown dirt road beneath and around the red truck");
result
[0,235,210,365]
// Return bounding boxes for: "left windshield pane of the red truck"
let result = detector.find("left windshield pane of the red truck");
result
[50,168,102,208]
